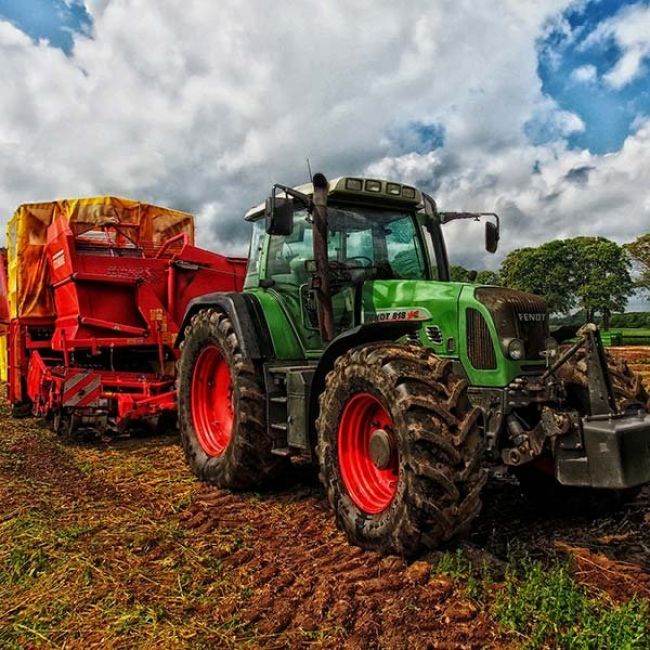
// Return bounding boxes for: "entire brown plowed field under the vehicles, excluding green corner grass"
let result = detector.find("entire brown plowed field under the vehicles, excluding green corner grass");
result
[0,388,650,648]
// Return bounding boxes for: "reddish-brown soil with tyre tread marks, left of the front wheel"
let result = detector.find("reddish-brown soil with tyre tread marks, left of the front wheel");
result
[181,487,505,648]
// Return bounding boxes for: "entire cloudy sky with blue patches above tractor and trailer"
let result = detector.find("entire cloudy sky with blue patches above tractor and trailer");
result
[0,0,650,302]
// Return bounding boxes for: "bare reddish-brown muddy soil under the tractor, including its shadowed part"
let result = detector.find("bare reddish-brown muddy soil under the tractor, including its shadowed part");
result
[182,460,650,648]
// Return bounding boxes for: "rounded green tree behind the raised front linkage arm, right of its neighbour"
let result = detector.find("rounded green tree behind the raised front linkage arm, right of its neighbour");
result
[569,237,634,330]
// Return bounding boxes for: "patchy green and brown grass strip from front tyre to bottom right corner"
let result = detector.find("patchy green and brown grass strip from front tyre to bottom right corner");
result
[434,550,650,650]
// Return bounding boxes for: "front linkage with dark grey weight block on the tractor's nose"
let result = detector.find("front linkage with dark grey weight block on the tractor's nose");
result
[488,323,650,490]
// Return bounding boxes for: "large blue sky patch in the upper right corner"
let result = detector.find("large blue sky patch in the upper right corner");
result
[528,0,650,154]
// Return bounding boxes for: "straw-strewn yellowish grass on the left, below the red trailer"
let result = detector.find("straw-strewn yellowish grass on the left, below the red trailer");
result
[0,406,255,648]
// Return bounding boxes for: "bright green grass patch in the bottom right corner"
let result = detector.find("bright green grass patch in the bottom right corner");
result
[493,559,650,650]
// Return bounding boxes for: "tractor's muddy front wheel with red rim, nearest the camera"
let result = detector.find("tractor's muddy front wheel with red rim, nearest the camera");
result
[316,342,487,556]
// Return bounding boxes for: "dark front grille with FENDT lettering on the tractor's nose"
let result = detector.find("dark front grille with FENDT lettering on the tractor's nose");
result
[475,287,548,361]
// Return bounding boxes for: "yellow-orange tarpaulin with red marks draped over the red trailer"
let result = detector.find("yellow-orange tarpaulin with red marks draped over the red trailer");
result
[7,196,194,318]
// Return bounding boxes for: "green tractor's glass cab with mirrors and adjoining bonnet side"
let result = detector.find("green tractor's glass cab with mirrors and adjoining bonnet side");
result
[240,177,498,359]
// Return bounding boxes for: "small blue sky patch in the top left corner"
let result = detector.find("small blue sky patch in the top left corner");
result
[0,0,92,55]
